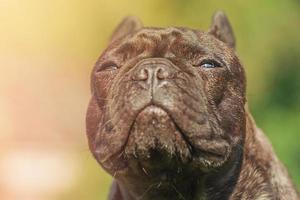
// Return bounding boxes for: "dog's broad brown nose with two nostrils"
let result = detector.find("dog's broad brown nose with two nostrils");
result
[132,59,174,84]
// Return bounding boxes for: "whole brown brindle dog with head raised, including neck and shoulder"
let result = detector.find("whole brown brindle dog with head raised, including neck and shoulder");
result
[87,12,299,200]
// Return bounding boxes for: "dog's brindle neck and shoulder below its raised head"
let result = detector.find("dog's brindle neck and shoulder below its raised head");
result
[109,112,296,200]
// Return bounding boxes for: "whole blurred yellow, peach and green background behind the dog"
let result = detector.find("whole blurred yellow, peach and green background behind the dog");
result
[0,0,300,200]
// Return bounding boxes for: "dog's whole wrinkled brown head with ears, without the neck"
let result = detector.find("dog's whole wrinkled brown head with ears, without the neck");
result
[87,12,245,192]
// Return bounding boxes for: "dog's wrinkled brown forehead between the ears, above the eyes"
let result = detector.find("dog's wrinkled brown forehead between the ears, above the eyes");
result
[116,27,207,58]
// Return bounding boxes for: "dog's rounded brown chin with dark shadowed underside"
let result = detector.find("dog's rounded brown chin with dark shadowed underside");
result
[125,105,191,180]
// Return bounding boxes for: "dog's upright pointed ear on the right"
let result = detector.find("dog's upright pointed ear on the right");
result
[209,11,235,48]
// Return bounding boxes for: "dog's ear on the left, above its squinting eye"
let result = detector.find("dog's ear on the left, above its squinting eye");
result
[110,16,143,42]
